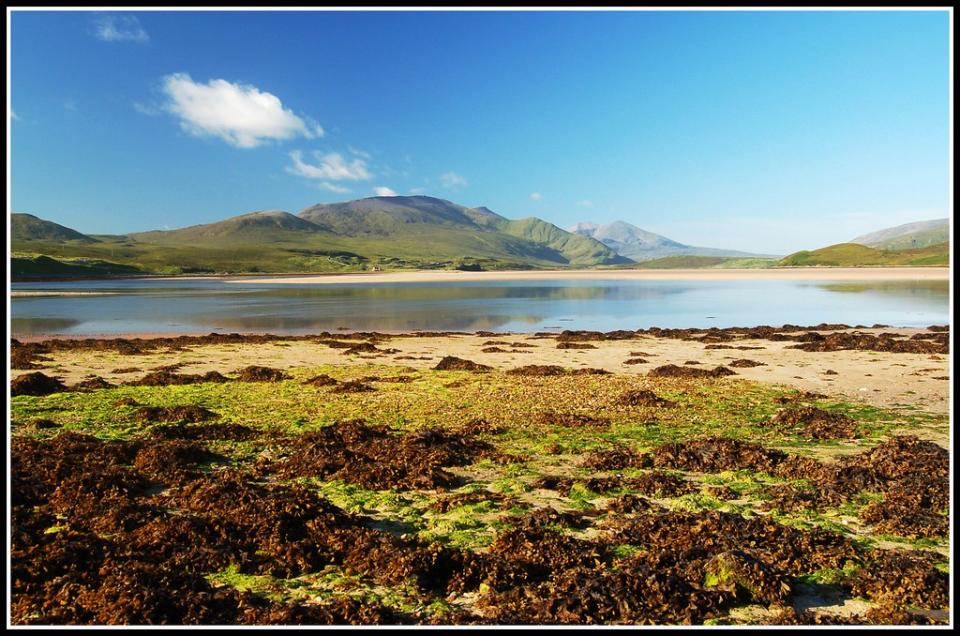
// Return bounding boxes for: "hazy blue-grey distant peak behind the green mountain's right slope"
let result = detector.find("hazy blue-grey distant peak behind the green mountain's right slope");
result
[570,221,773,263]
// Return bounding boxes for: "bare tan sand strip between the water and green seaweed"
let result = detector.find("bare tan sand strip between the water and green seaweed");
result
[11,325,952,413]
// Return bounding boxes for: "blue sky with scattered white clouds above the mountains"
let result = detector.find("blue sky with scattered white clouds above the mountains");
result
[10,11,951,253]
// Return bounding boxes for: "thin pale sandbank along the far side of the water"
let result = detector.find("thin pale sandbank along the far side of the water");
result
[219,267,950,285]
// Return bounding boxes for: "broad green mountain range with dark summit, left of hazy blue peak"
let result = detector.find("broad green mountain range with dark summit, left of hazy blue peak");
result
[11,196,631,274]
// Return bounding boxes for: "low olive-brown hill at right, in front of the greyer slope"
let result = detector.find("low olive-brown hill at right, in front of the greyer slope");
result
[777,243,950,267]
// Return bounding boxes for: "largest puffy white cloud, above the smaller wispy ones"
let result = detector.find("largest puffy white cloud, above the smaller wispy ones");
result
[161,73,323,148]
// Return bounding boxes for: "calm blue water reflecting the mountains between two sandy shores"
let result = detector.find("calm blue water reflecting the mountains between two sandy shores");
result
[10,280,949,337]
